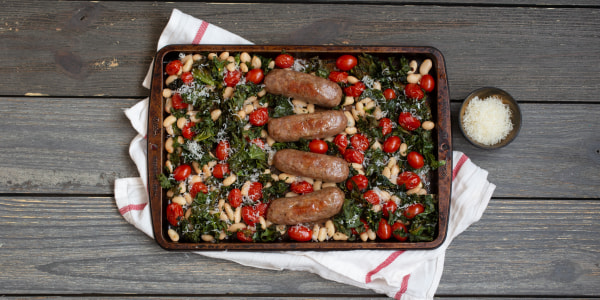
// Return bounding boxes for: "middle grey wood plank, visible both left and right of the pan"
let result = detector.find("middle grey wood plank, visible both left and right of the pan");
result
[0,97,600,198]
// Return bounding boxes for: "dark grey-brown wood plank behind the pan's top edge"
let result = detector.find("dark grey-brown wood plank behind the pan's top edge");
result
[0,0,600,102]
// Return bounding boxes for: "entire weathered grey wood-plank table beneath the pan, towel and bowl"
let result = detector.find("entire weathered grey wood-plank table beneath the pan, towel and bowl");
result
[0,0,600,299]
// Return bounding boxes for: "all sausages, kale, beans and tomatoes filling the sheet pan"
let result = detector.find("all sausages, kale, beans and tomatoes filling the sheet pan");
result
[159,52,444,243]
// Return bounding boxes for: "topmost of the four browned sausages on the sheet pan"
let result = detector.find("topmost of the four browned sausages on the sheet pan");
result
[264,69,344,107]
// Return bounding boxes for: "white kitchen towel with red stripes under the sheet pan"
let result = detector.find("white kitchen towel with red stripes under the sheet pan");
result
[115,9,496,300]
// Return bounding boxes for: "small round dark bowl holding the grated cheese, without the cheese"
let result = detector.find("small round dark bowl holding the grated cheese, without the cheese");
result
[458,87,521,150]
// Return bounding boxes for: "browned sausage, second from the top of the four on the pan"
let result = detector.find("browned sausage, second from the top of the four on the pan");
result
[268,110,348,142]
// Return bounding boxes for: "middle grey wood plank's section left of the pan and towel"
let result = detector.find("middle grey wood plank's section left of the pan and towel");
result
[0,98,139,194]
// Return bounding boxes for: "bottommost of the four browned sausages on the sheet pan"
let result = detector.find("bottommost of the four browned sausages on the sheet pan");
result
[267,187,344,225]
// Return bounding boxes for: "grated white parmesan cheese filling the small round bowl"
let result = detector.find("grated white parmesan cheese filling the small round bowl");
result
[462,96,513,146]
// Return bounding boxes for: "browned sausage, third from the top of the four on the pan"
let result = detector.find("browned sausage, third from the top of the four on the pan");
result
[273,149,350,183]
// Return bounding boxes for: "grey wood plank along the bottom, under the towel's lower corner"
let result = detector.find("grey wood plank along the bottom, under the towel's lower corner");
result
[0,196,600,297]
